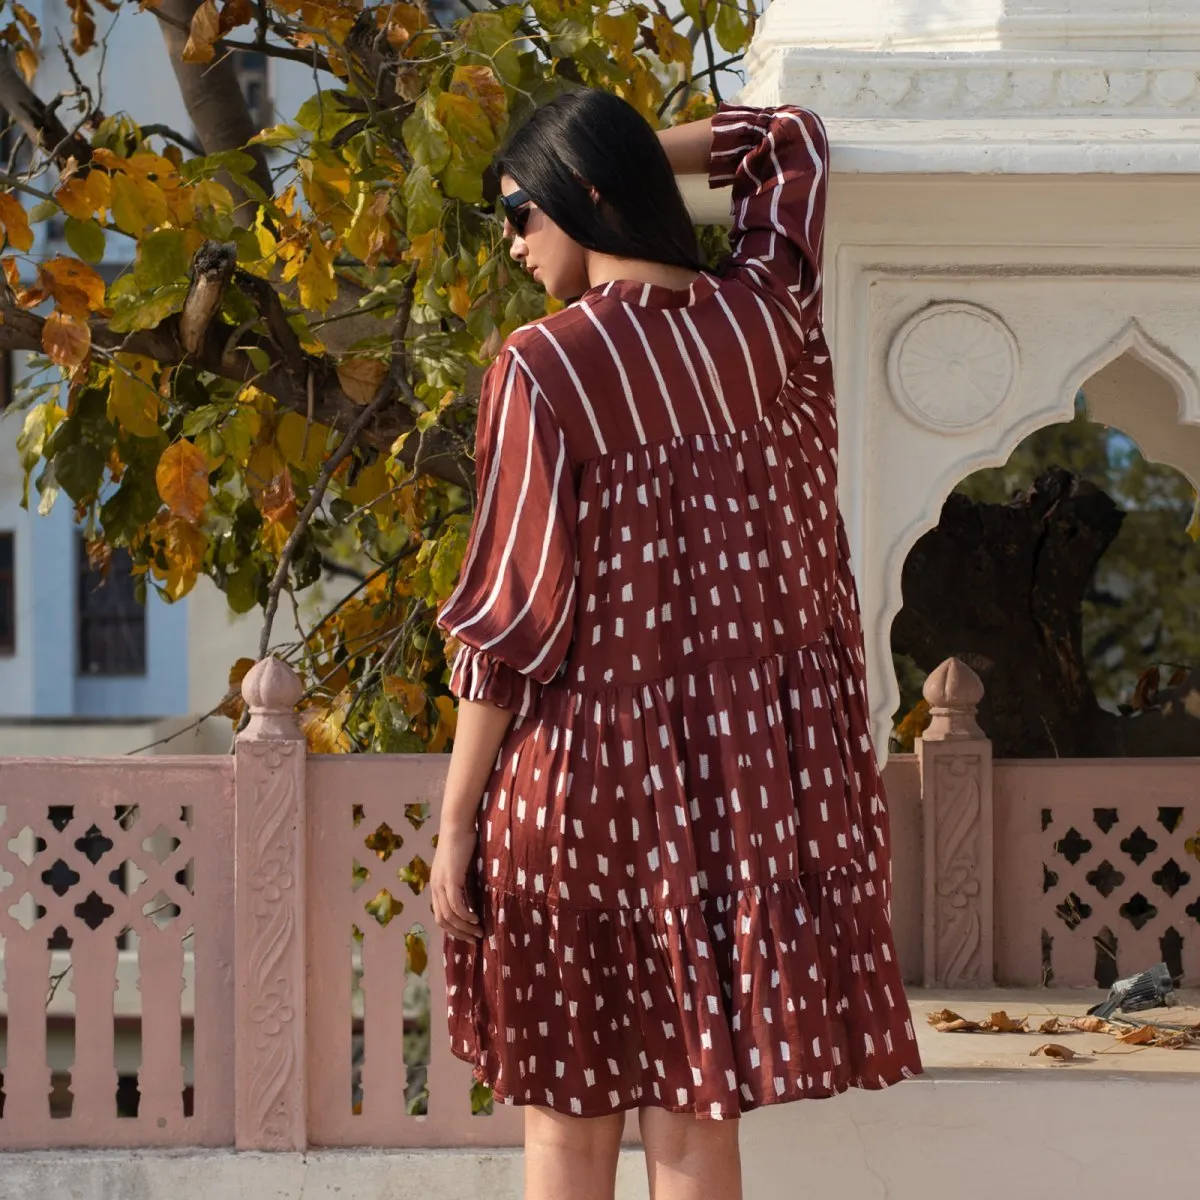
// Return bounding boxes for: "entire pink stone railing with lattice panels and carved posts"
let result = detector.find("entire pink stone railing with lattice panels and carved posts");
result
[0,660,1200,1150]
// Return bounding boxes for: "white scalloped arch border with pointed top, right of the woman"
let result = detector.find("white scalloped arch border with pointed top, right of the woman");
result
[868,320,1200,755]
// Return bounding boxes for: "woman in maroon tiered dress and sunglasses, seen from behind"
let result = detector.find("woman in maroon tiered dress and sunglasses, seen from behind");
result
[432,91,920,1200]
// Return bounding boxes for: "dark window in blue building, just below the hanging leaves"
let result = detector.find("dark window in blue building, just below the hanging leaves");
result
[78,534,146,676]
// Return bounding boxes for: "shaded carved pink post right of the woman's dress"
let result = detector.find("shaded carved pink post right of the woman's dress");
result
[917,659,994,988]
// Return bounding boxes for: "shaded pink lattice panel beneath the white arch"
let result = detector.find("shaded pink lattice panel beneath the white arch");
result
[995,760,1200,988]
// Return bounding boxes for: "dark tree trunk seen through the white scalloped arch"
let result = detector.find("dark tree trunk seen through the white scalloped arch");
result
[892,468,1200,758]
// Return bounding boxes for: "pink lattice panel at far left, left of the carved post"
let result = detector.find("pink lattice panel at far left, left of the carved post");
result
[0,757,233,1147]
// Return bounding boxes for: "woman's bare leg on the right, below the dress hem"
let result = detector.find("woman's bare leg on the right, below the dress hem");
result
[638,1108,742,1200]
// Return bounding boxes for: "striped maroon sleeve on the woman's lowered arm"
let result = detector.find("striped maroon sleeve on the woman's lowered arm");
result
[438,352,576,714]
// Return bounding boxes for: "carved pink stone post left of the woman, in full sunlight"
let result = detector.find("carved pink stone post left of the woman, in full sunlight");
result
[234,659,308,1151]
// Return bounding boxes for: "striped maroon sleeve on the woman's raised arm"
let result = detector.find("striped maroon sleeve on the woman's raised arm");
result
[709,104,829,328]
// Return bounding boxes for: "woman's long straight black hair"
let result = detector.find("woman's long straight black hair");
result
[496,89,704,270]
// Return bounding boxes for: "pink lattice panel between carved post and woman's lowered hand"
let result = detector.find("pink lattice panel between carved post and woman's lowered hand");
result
[307,755,522,1146]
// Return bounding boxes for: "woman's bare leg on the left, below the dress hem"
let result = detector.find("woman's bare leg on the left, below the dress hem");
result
[526,1105,625,1200]
